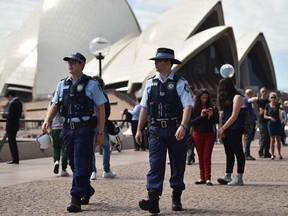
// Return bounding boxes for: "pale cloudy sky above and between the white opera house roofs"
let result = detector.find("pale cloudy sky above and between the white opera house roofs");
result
[0,0,288,92]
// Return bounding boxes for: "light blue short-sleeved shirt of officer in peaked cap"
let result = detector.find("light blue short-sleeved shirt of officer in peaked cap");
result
[52,73,107,122]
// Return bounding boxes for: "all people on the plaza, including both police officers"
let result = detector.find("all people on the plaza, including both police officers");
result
[3,48,287,214]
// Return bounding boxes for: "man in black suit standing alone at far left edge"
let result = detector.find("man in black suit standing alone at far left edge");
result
[2,91,23,164]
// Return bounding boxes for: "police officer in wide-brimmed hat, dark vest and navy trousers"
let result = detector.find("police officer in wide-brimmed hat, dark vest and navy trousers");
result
[135,48,193,213]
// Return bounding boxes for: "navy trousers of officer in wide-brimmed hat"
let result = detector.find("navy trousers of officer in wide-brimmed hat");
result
[146,126,187,196]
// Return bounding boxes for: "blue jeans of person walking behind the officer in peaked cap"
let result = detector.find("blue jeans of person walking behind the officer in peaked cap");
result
[92,125,110,173]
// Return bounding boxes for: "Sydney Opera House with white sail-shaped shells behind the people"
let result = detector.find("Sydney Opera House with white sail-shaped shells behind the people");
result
[0,0,277,101]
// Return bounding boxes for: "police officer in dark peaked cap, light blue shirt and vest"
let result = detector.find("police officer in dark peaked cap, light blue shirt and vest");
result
[42,53,106,212]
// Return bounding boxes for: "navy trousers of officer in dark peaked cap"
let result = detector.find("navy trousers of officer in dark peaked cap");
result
[61,126,95,198]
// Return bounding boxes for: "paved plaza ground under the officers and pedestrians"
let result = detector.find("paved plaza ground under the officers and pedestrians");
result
[0,140,288,216]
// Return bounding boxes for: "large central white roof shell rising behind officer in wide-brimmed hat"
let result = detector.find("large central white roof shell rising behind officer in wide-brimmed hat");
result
[98,0,224,88]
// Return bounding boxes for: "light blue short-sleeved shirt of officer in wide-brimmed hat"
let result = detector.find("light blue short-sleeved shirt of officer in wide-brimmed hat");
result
[140,71,194,108]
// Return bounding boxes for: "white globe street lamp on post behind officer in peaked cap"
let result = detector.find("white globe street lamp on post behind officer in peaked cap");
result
[89,37,110,78]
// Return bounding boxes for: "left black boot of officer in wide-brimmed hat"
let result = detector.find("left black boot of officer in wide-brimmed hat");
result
[139,190,160,214]
